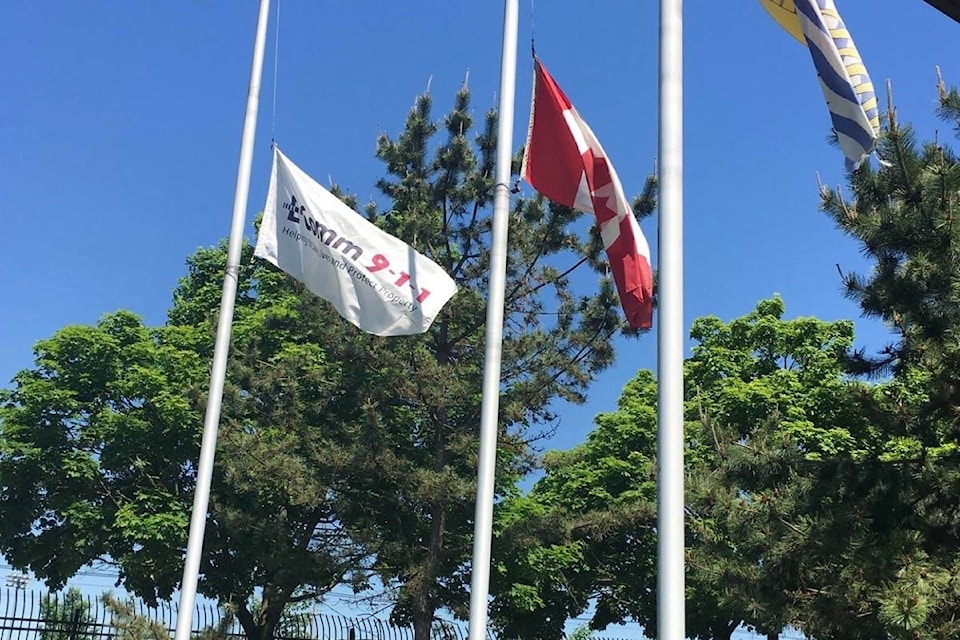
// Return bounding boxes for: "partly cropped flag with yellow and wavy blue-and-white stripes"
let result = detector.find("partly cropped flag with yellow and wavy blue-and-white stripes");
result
[760,0,880,169]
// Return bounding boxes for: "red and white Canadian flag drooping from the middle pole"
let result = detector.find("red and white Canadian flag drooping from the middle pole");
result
[520,60,653,329]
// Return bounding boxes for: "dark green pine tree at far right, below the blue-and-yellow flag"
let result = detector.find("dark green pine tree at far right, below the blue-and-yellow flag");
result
[652,76,960,639]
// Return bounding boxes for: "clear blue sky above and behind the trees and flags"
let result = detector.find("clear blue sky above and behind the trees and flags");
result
[0,0,960,628]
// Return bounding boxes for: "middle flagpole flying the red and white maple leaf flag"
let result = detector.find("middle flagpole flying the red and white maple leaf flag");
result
[469,0,519,640]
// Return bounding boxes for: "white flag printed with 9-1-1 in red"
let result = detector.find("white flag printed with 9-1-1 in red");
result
[254,147,457,336]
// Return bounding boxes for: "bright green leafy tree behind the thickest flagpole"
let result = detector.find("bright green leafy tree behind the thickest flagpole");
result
[495,298,890,640]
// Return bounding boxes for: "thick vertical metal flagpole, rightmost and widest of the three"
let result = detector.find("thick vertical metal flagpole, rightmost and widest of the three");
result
[657,0,685,640]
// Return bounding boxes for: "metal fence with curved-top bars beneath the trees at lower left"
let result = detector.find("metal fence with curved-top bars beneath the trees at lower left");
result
[0,588,472,640]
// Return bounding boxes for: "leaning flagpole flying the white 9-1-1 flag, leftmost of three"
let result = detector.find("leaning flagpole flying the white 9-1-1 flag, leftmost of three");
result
[174,0,270,640]
